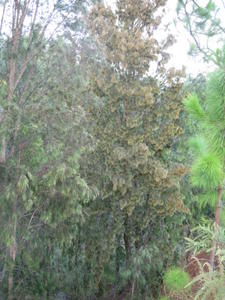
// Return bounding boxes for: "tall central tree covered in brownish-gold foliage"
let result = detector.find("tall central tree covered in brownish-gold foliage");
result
[86,0,187,296]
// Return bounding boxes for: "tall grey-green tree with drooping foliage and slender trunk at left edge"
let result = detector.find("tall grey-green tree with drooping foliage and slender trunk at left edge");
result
[0,0,95,299]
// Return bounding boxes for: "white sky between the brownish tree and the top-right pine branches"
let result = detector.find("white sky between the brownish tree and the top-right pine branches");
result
[104,0,222,75]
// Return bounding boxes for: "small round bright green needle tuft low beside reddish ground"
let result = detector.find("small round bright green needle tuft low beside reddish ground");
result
[164,267,190,291]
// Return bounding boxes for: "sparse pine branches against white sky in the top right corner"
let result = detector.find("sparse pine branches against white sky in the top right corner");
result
[177,0,225,65]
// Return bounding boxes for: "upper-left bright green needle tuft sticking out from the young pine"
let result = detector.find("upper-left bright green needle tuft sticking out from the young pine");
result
[183,94,205,121]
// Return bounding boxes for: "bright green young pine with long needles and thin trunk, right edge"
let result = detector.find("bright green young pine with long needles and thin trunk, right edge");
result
[184,69,225,267]
